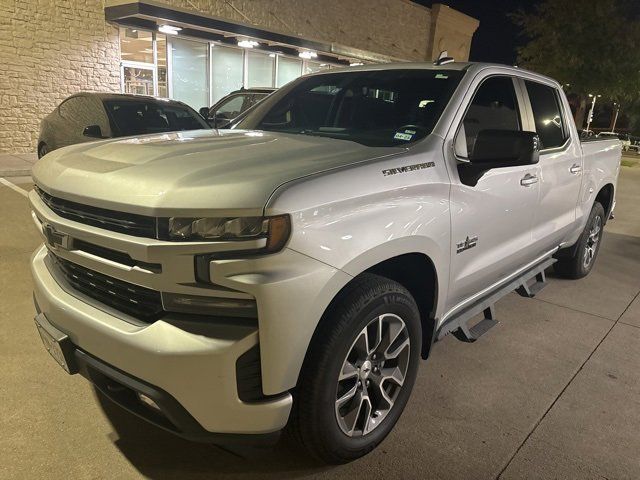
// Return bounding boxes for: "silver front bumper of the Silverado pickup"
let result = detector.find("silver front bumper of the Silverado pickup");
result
[31,246,292,437]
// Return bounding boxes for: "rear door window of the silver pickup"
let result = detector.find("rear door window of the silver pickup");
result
[525,80,567,149]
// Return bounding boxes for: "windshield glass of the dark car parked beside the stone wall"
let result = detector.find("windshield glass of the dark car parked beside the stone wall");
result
[104,100,210,136]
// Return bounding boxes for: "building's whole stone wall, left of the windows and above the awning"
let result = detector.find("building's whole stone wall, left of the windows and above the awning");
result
[0,0,477,153]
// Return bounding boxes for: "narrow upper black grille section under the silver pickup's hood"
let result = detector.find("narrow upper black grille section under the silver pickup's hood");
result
[36,187,157,238]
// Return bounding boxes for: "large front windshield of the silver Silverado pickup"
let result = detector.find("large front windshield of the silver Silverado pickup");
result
[236,69,463,146]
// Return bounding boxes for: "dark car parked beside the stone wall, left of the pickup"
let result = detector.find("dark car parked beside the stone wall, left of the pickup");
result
[38,93,211,157]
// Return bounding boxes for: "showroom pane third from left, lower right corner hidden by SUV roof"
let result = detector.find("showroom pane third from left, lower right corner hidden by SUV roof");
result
[211,44,244,103]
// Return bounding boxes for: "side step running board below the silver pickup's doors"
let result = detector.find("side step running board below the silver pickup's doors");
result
[436,257,556,342]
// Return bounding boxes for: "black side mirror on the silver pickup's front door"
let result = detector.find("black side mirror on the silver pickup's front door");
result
[458,130,540,186]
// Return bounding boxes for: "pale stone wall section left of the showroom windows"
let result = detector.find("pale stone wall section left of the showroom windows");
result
[0,0,120,153]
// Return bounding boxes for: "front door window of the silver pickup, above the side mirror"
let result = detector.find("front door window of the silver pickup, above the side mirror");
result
[455,77,521,158]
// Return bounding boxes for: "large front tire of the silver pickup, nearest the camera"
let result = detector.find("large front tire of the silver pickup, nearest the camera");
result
[287,274,422,464]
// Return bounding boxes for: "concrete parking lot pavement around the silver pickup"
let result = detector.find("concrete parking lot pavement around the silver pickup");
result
[0,167,640,480]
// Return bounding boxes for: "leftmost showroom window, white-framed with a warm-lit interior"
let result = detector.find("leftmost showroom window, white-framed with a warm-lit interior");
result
[120,28,156,95]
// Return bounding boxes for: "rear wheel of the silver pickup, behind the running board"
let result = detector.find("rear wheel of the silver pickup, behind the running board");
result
[553,202,606,279]
